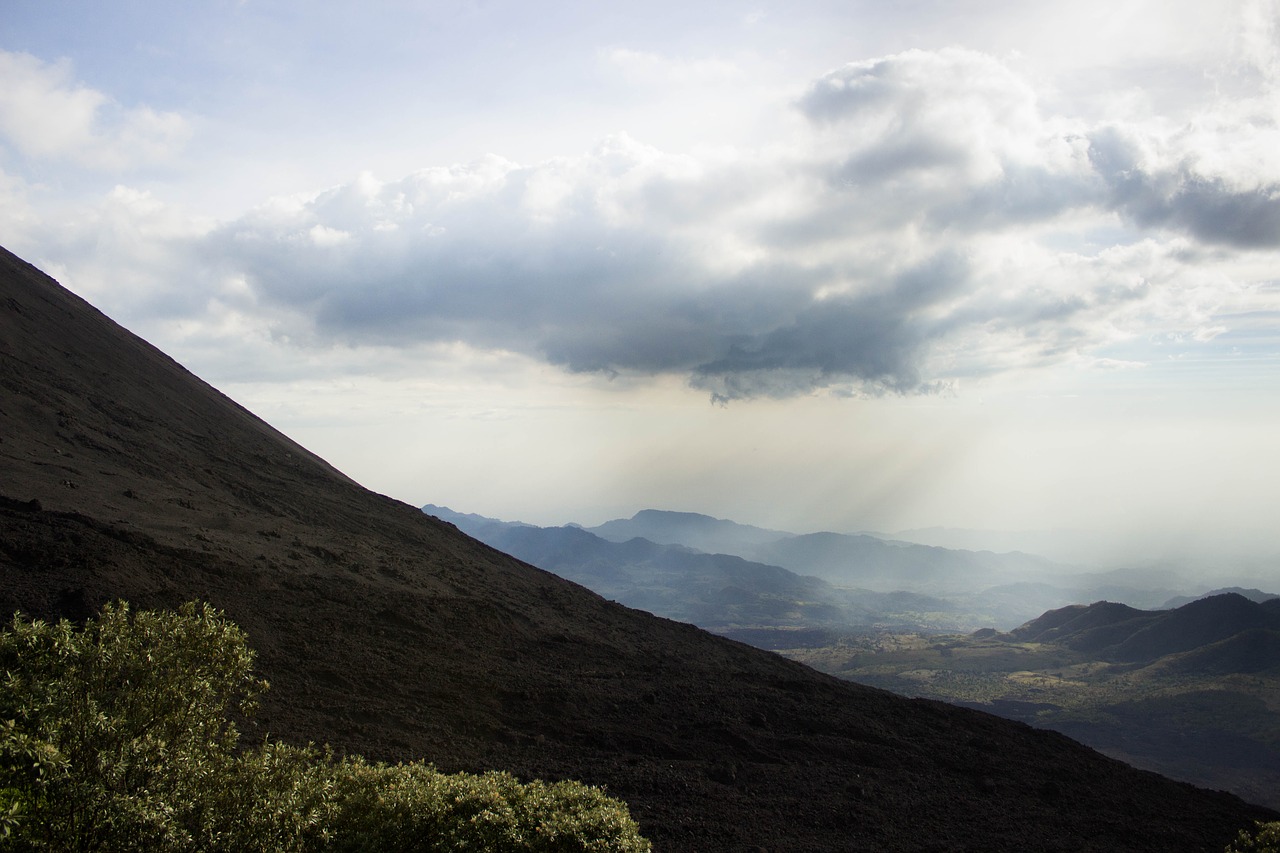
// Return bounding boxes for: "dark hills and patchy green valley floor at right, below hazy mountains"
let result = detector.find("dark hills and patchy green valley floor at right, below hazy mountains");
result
[787,593,1280,807]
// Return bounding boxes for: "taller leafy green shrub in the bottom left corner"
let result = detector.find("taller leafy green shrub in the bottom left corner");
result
[0,605,265,850]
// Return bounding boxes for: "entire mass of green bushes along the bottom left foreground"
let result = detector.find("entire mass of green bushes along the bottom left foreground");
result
[0,603,650,853]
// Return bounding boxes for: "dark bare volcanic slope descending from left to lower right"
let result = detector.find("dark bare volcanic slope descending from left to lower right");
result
[0,240,1270,850]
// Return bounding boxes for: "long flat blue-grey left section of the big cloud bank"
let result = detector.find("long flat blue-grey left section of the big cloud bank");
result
[207,153,963,398]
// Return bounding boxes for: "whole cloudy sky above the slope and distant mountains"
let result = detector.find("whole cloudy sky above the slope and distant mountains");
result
[0,0,1280,563]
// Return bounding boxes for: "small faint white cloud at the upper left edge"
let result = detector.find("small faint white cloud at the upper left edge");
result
[0,50,191,170]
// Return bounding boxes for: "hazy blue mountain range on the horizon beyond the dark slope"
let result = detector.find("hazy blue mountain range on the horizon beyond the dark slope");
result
[422,505,1198,630]
